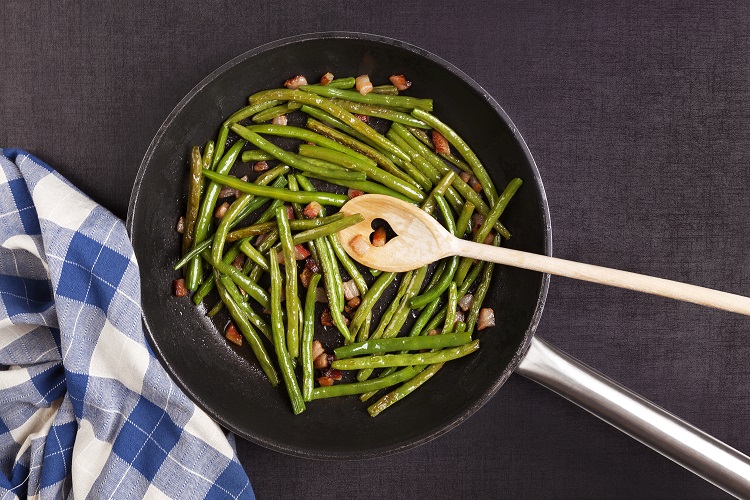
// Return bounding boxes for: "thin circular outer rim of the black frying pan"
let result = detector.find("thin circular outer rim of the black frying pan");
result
[126,31,552,460]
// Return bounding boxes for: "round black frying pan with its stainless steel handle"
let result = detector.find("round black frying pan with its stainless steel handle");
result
[127,33,750,496]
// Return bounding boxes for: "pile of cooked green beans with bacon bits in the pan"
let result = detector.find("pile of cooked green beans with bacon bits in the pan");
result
[174,72,521,416]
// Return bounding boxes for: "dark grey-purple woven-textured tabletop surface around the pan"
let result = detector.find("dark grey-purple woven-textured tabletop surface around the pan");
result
[0,0,750,499]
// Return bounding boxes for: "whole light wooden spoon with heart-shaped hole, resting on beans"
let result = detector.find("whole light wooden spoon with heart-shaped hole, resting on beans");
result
[339,194,750,315]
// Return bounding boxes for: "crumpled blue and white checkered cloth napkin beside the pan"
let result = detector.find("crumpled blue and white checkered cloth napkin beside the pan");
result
[0,149,253,499]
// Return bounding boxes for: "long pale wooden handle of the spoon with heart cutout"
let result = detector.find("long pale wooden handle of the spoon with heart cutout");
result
[454,239,750,316]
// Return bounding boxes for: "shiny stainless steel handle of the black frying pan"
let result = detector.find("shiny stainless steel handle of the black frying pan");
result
[516,337,750,498]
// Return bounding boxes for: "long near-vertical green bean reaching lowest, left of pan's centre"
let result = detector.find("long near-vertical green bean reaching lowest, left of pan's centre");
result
[269,247,305,415]
